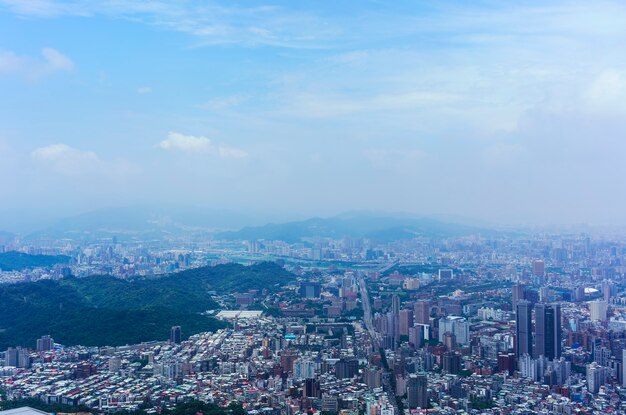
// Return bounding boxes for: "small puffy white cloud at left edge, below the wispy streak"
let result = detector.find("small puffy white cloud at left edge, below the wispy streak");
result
[0,48,74,79]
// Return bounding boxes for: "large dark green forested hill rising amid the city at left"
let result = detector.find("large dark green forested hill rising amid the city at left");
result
[0,263,293,350]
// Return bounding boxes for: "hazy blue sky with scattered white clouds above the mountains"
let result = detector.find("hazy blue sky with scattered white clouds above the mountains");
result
[0,0,626,229]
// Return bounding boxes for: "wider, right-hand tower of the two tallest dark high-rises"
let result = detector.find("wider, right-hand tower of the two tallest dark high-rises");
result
[534,304,561,360]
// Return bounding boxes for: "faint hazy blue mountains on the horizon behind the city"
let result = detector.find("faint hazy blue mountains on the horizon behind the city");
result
[8,207,495,242]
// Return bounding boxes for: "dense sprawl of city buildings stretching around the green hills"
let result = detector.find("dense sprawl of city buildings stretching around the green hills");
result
[0,228,626,415]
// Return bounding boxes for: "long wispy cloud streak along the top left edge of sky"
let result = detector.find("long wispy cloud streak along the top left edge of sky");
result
[0,0,339,48]
